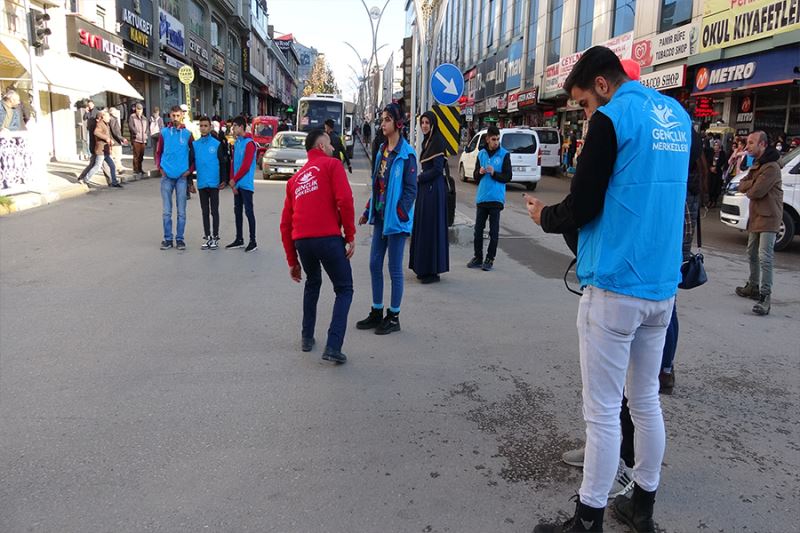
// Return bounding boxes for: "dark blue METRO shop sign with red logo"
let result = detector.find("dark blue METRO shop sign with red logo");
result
[692,46,800,94]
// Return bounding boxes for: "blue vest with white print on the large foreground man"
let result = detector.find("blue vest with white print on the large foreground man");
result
[577,81,692,301]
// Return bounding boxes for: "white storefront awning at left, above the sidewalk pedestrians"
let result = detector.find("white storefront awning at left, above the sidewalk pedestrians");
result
[37,54,144,100]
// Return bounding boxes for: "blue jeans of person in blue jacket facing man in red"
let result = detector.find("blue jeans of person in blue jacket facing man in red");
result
[369,220,408,313]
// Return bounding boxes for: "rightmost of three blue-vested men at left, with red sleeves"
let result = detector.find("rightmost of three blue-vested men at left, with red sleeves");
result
[225,116,258,252]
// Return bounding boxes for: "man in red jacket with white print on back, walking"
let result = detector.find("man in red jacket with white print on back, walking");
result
[281,130,356,364]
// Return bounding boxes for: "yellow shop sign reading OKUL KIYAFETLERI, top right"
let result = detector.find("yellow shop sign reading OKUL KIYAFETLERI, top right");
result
[700,0,800,52]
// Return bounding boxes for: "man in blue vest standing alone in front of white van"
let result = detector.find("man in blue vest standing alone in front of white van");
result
[467,126,511,272]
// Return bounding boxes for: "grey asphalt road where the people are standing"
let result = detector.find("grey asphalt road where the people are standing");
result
[0,143,800,533]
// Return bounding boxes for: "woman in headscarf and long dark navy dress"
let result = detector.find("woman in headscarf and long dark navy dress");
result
[408,111,450,283]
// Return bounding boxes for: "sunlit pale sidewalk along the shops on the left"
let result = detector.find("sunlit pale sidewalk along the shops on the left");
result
[0,154,156,216]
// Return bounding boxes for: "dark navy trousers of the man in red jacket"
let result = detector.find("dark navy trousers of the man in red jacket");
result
[294,237,353,350]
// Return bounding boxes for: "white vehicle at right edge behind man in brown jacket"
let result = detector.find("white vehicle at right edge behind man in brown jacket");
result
[719,148,800,251]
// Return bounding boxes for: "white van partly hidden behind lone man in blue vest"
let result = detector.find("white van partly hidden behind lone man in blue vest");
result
[458,127,542,191]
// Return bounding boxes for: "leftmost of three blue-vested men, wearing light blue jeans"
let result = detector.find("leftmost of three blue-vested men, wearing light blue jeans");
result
[156,106,194,250]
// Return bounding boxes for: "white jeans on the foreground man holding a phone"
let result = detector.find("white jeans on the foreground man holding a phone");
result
[578,286,675,508]
